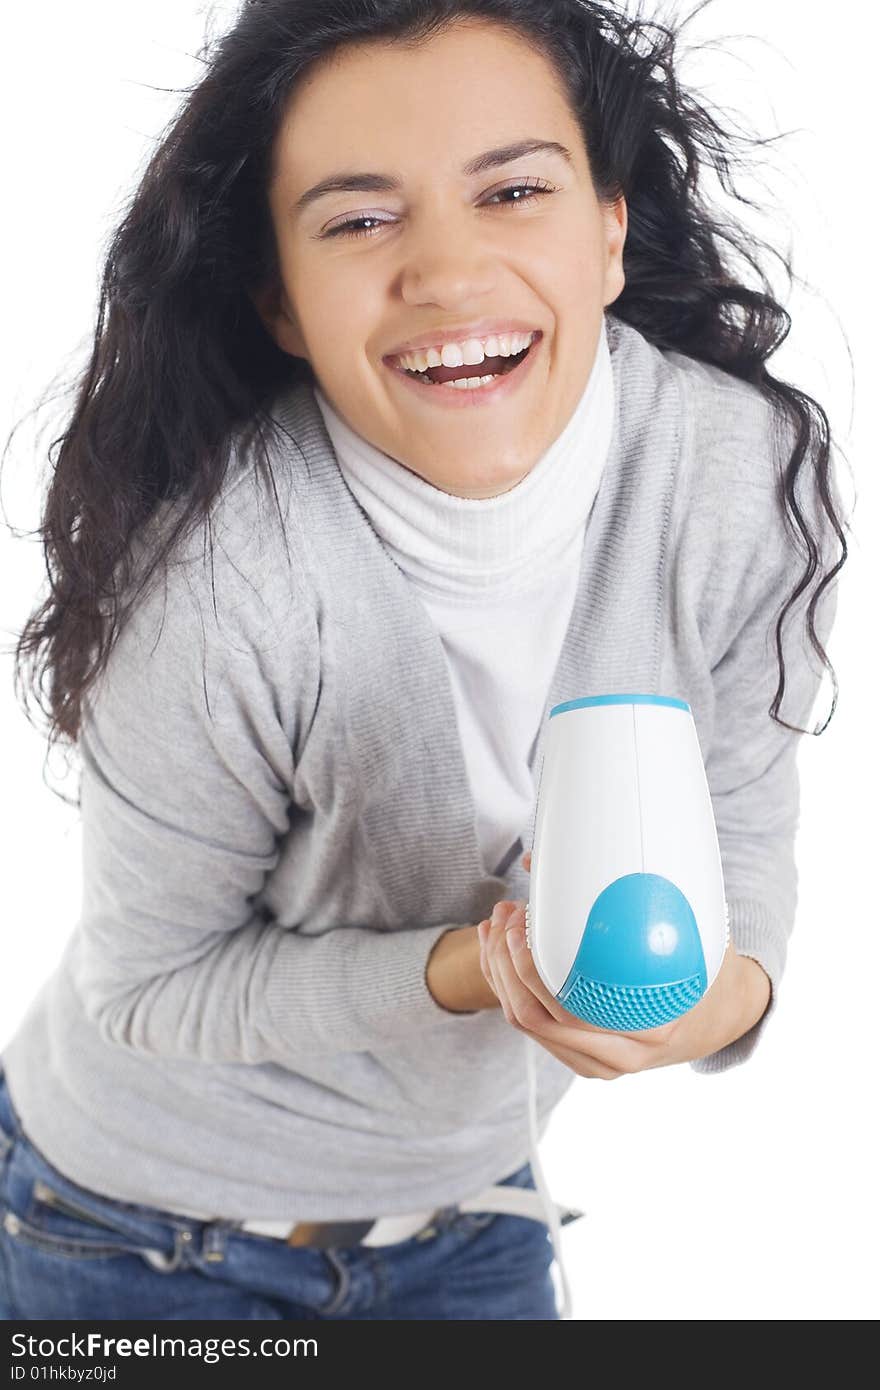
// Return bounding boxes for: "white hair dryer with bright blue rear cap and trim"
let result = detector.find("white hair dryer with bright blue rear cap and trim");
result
[525,695,728,1031]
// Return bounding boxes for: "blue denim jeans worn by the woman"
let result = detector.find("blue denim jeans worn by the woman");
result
[0,1068,559,1321]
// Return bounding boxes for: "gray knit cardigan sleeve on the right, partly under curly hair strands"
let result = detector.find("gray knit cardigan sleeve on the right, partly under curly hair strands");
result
[690,403,838,1073]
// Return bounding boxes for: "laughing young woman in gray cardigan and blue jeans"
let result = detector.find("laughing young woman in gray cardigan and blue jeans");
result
[0,0,847,1319]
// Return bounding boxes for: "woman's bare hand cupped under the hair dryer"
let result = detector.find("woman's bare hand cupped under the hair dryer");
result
[477,852,770,1081]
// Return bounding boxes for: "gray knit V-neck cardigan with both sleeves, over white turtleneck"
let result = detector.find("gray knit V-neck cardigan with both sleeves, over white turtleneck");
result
[3,316,836,1219]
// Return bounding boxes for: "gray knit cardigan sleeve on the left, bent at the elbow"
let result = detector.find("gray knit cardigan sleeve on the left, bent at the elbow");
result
[72,467,472,1068]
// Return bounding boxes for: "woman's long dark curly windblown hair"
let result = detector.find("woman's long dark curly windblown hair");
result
[4,0,847,806]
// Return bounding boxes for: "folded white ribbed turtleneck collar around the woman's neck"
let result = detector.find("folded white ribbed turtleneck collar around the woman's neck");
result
[313,317,614,603]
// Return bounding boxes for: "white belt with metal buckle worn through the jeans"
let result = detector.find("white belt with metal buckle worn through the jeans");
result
[236,1186,584,1248]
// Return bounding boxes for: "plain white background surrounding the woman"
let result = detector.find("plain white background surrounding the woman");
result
[0,0,880,1319]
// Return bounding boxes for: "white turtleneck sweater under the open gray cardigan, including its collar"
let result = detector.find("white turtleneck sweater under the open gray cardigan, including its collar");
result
[314,318,614,874]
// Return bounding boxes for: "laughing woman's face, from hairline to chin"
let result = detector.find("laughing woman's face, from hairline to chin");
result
[254,19,626,498]
